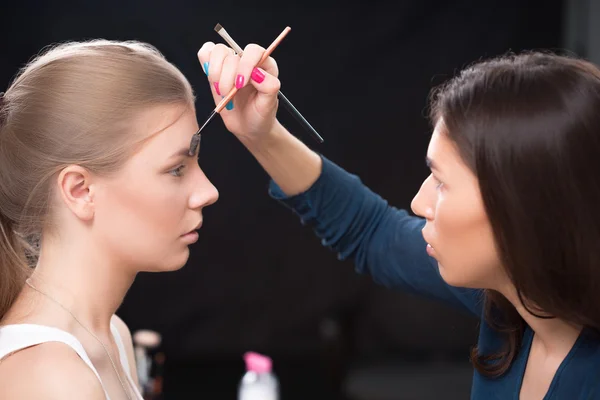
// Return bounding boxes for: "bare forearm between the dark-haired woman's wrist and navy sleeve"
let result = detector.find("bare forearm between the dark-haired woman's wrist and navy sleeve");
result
[241,121,322,196]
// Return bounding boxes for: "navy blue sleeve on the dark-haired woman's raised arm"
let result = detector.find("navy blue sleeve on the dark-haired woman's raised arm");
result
[269,157,483,317]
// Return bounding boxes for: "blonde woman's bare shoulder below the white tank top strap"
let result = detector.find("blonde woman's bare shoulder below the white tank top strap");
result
[0,342,106,400]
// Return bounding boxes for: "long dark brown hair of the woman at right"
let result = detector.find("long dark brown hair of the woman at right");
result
[431,52,600,377]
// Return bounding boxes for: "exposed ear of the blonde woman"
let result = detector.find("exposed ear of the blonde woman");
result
[57,165,94,221]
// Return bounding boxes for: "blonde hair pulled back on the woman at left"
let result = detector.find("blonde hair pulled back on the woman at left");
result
[0,40,194,319]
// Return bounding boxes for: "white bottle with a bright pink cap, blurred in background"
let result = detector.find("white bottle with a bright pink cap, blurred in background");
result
[238,352,279,400]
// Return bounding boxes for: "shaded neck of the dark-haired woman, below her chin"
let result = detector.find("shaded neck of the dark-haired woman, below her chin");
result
[500,285,582,354]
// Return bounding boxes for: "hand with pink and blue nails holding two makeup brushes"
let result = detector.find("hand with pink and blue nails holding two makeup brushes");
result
[198,42,281,141]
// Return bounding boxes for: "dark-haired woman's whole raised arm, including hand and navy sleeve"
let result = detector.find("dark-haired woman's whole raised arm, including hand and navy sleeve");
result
[198,42,481,315]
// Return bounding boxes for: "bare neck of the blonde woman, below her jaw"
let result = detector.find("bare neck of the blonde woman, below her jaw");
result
[30,231,135,334]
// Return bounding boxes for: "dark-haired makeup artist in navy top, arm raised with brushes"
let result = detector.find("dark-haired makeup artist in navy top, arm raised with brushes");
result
[198,43,600,399]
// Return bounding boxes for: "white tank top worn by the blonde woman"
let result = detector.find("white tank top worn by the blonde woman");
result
[0,324,143,400]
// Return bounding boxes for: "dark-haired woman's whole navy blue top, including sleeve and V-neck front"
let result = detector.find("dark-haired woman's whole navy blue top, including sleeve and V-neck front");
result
[269,157,600,400]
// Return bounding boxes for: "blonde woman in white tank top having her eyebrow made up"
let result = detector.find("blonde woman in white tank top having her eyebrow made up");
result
[0,41,218,400]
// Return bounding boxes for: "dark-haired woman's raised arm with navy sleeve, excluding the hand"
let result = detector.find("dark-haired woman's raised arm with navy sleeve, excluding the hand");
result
[246,126,482,316]
